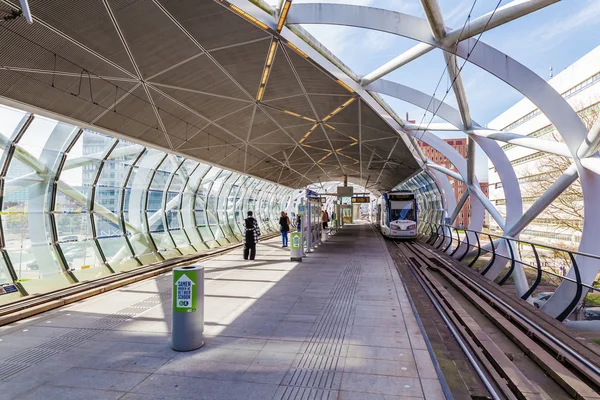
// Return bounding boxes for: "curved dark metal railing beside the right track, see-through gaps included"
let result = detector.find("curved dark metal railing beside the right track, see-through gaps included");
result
[421,222,600,321]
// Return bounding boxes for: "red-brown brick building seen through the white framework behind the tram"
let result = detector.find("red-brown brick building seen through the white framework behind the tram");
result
[419,138,489,228]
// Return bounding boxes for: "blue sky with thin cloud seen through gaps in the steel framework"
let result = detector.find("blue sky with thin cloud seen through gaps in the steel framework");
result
[267,0,600,181]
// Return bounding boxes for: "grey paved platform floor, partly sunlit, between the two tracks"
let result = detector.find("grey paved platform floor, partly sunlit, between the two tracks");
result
[0,223,444,400]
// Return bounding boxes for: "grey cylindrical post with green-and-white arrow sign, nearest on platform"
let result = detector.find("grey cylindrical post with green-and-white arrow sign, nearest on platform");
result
[171,265,204,351]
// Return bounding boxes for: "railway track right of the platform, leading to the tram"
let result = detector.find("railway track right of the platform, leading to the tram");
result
[388,241,600,399]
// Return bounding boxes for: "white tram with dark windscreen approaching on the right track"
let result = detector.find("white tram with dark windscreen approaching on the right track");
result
[374,191,417,239]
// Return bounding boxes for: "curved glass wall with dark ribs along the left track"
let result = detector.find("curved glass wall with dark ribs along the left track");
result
[0,106,292,304]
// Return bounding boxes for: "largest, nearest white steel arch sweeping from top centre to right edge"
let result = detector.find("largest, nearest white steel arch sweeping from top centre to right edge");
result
[284,1,600,316]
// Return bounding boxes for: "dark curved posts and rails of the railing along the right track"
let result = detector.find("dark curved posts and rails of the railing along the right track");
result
[425,222,600,321]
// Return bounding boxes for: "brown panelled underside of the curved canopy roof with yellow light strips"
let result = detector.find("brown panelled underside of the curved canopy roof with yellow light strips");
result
[0,0,421,191]
